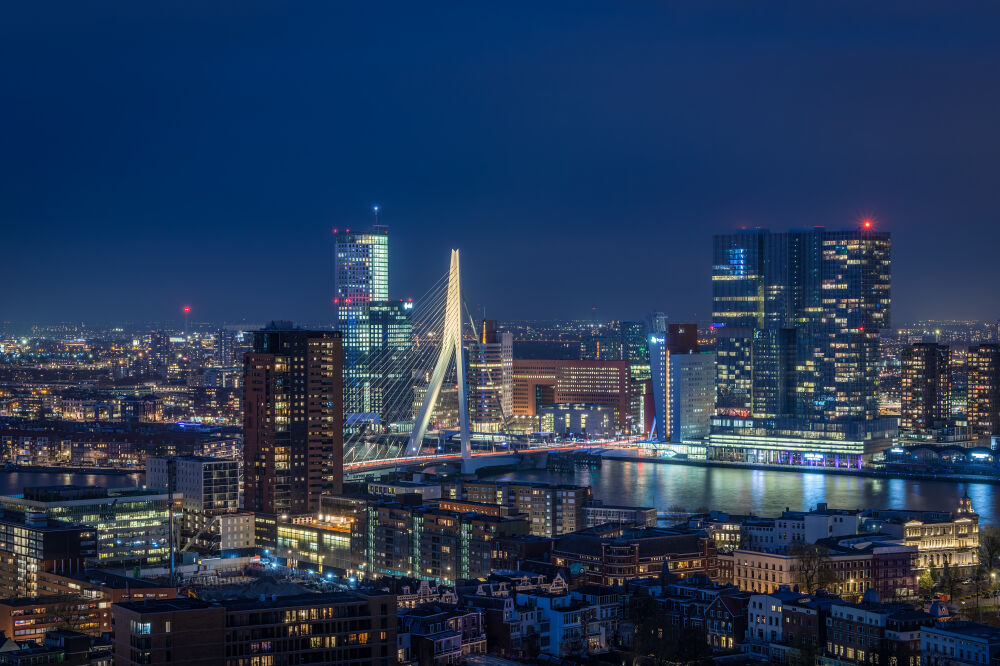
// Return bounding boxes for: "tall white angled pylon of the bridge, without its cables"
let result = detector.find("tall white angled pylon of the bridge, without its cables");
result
[406,250,472,472]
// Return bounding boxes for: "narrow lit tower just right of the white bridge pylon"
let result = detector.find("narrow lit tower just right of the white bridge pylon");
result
[468,319,514,432]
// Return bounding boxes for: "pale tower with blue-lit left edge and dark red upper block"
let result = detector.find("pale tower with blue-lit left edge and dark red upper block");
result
[649,324,715,442]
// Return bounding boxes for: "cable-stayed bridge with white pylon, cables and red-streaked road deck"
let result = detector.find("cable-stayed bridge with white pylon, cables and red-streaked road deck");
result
[344,250,632,473]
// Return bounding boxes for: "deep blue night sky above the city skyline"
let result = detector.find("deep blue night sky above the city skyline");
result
[0,0,1000,323]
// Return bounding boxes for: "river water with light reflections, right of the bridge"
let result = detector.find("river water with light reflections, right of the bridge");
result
[480,460,1000,525]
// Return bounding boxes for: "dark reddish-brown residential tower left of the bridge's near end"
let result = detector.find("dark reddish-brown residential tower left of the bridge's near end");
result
[243,322,344,514]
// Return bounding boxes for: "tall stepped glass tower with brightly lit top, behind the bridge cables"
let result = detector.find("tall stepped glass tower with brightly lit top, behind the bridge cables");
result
[333,226,413,430]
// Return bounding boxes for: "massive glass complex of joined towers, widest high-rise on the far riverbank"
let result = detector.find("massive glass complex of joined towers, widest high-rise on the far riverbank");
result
[709,223,898,468]
